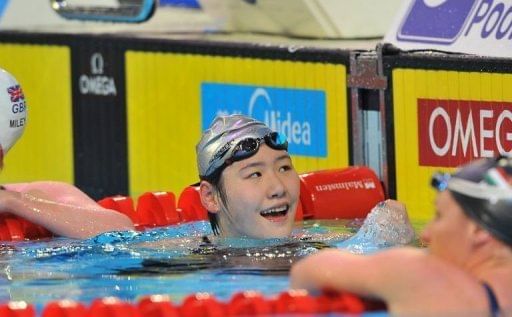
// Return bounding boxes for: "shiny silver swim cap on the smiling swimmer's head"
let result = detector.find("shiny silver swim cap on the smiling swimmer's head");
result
[196,114,273,178]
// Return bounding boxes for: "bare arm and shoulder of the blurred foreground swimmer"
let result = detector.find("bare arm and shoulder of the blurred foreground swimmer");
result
[290,248,494,316]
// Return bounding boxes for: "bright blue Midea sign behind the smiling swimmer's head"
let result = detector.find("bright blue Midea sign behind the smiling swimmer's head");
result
[201,83,327,157]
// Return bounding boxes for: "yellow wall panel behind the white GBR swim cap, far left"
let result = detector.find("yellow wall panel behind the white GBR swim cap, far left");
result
[0,44,73,183]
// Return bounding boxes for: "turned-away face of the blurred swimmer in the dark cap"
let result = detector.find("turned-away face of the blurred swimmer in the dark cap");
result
[421,191,477,267]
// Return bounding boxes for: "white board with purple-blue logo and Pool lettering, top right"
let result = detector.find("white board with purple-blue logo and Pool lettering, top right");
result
[385,0,512,57]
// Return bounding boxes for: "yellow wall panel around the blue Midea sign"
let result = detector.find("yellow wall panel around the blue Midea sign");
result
[126,51,349,195]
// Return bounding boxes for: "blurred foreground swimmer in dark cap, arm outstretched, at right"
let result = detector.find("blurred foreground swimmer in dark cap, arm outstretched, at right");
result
[291,157,512,316]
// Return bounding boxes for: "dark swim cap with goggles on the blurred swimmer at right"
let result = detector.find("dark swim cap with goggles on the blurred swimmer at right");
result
[432,157,512,246]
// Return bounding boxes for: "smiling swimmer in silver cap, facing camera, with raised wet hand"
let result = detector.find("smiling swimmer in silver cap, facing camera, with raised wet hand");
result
[124,115,414,274]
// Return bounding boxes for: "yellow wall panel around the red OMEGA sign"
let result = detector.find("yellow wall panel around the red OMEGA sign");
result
[392,69,512,222]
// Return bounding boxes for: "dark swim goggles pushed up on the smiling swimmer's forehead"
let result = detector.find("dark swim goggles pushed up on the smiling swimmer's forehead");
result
[206,132,288,175]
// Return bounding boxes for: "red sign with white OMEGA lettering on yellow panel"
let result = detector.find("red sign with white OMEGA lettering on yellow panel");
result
[417,98,512,167]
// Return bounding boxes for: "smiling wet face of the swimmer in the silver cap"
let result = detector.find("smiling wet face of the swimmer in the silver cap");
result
[211,144,300,238]
